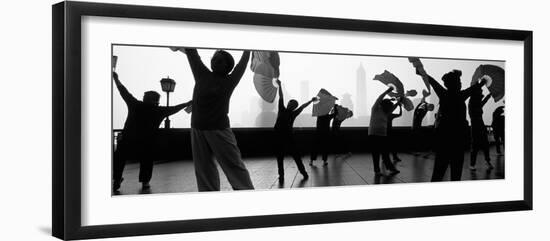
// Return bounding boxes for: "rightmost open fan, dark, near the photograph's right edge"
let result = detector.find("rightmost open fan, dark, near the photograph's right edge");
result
[471,64,504,102]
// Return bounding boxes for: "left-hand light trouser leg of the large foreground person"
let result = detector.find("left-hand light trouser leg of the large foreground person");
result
[191,129,220,192]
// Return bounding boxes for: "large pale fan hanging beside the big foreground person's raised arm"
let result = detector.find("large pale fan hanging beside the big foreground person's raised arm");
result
[250,51,280,103]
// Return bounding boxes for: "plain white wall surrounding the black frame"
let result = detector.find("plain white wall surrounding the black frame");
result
[0,0,550,241]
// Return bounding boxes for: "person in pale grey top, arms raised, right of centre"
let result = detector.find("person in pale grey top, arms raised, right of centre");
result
[369,87,399,176]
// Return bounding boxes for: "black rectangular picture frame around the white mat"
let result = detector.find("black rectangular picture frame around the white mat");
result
[52,2,533,240]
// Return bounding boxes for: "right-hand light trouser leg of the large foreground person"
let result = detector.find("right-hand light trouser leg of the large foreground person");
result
[205,128,254,190]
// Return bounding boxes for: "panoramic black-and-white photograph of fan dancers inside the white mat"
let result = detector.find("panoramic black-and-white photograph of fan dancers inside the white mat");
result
[110,44,506,195]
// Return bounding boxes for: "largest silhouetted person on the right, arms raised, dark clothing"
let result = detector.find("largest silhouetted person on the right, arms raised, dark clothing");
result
[428,70,485,182]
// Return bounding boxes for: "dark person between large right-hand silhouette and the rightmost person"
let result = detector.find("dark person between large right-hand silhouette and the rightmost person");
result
[468,88,493,170]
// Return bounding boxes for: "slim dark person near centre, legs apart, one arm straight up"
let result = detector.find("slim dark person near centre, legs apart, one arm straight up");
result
[274,80,315,181]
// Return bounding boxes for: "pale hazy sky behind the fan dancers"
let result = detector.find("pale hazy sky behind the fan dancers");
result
[110,45,505,129]
